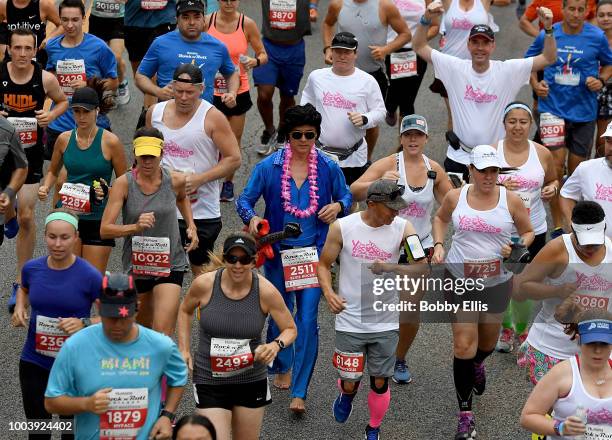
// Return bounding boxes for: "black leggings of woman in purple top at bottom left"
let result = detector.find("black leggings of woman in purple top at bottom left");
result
[19,360,74,440]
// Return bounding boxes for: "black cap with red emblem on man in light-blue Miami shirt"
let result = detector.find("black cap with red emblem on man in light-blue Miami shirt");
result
[100,272,137,318]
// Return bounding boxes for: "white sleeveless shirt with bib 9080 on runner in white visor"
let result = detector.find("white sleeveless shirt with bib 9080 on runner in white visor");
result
[527,234,612,359]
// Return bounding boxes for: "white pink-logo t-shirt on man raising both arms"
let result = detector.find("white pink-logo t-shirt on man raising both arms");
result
[431,49,533,165]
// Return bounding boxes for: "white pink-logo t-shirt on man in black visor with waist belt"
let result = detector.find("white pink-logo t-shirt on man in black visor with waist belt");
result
[300,67,387,168]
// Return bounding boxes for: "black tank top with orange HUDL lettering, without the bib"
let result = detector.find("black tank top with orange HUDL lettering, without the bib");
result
[0,61,46,145]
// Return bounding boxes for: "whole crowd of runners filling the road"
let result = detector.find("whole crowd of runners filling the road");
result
[0,0,612,440]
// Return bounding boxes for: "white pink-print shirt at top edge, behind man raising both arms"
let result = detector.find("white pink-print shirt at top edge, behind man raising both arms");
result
[440,0,489,60]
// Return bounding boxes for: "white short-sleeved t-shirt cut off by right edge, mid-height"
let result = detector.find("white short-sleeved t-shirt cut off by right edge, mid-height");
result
[561,157,612,238]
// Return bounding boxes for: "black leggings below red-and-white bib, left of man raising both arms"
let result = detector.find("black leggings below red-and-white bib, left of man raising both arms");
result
[385,50,427,118]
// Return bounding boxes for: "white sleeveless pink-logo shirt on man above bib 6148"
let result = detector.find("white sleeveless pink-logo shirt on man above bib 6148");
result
[336,212,406,333]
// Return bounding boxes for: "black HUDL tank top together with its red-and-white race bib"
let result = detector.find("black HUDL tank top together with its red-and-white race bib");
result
[0,62,46,148]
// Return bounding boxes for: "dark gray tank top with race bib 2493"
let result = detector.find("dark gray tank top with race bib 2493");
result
[193,269,268,385]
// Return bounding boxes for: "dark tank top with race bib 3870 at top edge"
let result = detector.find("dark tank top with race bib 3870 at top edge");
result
[261,0,312,42]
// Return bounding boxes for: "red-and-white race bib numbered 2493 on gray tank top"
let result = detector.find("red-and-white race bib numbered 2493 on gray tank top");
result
[210,338,253,377]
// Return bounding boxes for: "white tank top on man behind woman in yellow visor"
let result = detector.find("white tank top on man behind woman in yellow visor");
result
[151,100,221,220]
